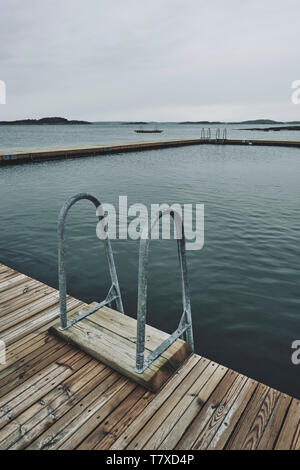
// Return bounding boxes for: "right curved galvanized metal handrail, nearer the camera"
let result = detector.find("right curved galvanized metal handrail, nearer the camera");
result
[135,209,194,373]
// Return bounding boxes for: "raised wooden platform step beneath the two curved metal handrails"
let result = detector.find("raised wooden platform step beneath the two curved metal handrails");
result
[50,302,191,392]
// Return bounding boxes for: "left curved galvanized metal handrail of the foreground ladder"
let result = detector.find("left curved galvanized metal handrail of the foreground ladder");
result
[58,193,124,330]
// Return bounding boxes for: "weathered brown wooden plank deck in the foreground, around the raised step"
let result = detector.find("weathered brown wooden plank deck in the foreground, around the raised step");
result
[0,264,300,450]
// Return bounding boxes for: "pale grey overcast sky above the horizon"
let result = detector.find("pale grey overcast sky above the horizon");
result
[0,0,300,121]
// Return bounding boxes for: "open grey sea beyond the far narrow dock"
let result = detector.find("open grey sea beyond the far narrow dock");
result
[0,122,300,151]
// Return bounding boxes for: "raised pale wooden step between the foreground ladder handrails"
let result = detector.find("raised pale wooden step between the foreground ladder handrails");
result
[50,306,190,391]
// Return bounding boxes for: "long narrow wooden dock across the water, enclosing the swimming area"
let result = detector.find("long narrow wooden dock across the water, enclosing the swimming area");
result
[0,138,300,165]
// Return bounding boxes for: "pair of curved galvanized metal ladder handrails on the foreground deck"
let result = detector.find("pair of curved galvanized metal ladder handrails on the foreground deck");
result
[58,193,194,373]
